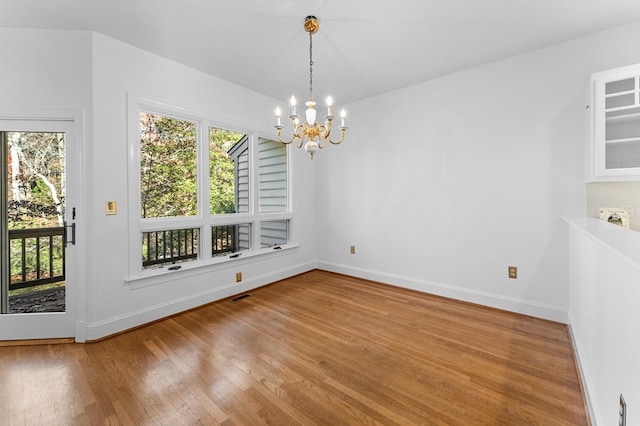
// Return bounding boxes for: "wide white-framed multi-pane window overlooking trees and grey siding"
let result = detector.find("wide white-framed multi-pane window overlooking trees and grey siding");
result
[129,97,293,279]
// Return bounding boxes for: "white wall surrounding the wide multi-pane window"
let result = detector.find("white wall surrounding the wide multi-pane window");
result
[86,34,315,339]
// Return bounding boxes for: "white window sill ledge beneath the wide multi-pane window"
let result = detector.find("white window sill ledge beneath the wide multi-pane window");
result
[125,244,299,289]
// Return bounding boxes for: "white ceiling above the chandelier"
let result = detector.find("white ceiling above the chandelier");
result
[0,0,640,105]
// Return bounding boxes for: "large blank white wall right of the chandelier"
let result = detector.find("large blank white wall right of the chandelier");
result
[318,18,640,321]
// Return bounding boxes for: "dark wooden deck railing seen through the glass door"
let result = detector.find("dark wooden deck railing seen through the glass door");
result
[9,226,65,290]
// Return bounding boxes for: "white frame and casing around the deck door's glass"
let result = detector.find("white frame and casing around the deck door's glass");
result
[0,109,87,342]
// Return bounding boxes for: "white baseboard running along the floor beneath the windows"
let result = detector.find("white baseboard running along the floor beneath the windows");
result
[82,262,316,342]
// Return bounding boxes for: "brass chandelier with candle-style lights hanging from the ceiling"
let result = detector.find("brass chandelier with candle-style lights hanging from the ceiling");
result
[273,16,347,160]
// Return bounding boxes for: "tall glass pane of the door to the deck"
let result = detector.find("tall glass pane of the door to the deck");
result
[3,132,66,313]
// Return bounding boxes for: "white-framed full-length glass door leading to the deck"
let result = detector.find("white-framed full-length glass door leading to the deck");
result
[0,120,75,340]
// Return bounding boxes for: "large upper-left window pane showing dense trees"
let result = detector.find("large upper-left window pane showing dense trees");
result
[140,112,198,218]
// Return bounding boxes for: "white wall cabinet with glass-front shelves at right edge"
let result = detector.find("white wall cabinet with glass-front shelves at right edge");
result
[587,64,640,181]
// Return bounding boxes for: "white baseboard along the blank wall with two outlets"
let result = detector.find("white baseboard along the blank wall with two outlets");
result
[317,262,569,324]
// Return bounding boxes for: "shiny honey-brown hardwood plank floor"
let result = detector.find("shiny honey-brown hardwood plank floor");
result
[0,271,588,426]
